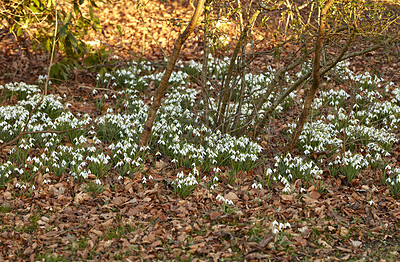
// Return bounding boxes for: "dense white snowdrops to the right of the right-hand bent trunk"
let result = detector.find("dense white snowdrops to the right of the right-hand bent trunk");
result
[288,62,400,184]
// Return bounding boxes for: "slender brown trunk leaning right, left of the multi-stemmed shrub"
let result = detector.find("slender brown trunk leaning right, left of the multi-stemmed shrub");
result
[139,0,206,147]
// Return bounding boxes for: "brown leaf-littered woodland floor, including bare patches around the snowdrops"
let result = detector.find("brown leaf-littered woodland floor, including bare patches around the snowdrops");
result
[0,1,400,261]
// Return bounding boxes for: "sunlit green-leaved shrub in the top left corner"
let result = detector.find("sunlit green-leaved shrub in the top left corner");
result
[0,0,107,80]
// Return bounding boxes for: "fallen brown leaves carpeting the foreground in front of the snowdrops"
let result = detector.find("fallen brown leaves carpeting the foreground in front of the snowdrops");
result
[0,2,400,261]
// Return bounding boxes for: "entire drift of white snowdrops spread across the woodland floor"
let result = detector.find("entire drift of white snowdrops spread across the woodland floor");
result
[0,57,400,196]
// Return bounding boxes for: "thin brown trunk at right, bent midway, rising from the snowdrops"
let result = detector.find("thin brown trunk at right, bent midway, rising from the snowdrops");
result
[289,0,334,152]
